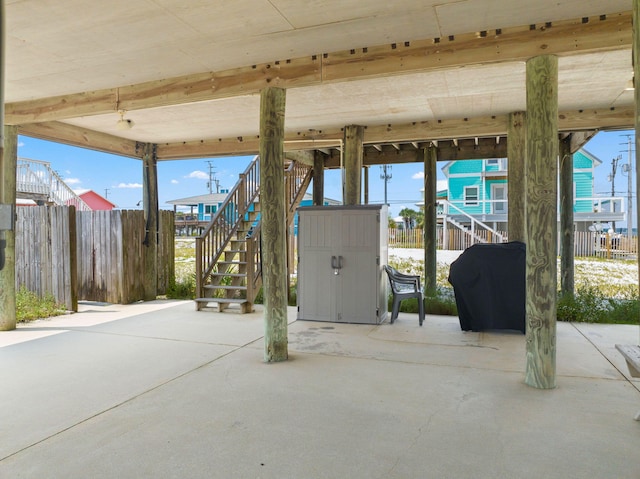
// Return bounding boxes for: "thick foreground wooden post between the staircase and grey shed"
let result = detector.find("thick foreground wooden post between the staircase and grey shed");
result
[260,88,288,363]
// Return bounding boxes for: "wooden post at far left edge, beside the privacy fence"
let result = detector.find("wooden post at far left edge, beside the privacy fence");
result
[0,125,18,331]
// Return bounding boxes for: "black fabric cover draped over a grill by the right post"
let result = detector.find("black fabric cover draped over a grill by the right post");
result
[449,241,526,333]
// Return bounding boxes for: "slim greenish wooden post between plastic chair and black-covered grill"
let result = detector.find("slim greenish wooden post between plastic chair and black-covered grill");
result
[422,144,438,296]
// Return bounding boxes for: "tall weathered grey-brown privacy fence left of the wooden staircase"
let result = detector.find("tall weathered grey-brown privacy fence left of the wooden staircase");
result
[16,206,175,311]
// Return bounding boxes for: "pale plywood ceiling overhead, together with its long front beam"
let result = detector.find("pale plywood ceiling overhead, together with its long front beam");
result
[5,0,633,156]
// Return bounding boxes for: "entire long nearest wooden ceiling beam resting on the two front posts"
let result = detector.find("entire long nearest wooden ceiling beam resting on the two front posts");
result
[5,12,632,125]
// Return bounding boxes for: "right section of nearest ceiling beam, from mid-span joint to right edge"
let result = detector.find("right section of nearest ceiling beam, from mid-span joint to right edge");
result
[322,12,632,81]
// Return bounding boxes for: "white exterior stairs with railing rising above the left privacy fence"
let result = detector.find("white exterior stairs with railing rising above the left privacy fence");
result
[16,158,91,211]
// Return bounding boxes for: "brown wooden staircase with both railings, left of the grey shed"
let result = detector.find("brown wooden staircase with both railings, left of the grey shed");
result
[195,156,312,313]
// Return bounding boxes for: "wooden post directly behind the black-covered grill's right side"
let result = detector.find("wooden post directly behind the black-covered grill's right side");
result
[507,111,527,242]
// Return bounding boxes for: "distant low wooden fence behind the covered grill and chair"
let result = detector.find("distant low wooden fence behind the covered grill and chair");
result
[389,228,638,259]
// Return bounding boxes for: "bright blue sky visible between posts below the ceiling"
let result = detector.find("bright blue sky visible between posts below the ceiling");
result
[18,131,635,221]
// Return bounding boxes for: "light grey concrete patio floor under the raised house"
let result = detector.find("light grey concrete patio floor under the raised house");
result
[0,301,640,479]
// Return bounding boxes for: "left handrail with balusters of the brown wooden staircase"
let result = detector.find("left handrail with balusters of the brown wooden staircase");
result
[196,156,260,297]
